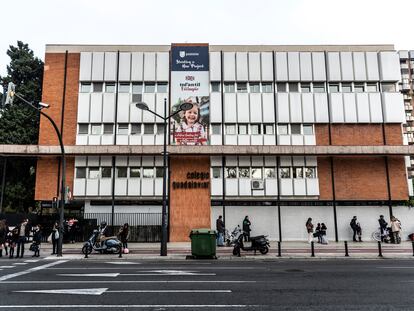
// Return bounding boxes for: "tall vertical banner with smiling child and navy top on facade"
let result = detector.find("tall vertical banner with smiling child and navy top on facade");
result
[170,44,210,146]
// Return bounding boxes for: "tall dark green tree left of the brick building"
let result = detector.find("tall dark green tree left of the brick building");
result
[0,41,43,212]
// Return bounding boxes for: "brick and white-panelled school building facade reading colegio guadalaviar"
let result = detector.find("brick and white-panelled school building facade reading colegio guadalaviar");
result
[36,44,414,241]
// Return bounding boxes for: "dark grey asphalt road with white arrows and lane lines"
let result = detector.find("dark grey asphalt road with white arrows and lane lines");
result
[0,257,414,311]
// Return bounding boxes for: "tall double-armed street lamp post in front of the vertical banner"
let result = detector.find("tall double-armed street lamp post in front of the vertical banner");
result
[136,98,193,256]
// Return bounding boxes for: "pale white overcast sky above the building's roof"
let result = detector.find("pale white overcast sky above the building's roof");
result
[0,0,414,75]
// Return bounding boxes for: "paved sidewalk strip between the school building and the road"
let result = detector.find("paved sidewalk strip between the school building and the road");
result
[41,241,413,260]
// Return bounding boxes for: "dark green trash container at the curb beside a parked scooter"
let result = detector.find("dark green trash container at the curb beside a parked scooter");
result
[190,229,217,259]
